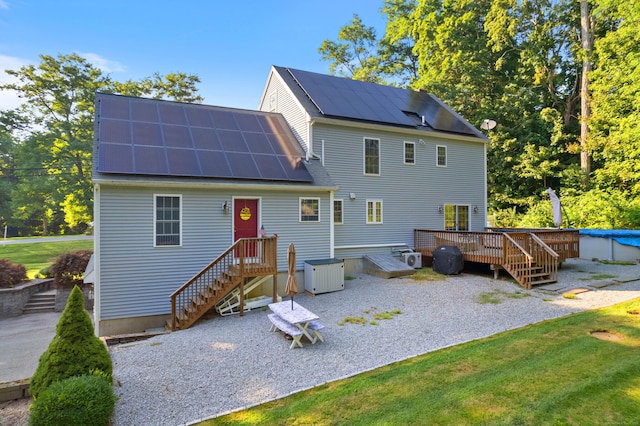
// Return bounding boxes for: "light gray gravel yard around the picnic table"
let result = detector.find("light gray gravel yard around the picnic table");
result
[106,259,640,425]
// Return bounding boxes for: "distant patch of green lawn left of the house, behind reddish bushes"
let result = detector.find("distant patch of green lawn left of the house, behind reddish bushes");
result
[0,240,93,279]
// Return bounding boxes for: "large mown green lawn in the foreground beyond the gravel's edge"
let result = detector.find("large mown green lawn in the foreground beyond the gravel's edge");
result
[201,299,640,426]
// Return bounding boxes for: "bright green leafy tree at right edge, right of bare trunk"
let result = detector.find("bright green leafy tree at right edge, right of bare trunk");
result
[588,0,640,199]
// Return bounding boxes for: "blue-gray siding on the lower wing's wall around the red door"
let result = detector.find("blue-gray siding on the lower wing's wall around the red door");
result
[96,184,331,320]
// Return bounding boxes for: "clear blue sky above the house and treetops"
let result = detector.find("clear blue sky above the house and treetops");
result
[0,0,385,109]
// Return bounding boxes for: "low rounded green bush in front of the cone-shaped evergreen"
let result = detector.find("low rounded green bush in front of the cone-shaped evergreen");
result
[29,375,116,426]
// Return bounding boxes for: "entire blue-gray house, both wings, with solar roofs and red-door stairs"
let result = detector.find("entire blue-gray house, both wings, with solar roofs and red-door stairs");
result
[93,67,487,336]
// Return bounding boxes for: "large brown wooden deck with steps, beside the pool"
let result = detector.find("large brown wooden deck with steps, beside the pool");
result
[414,228,580,288]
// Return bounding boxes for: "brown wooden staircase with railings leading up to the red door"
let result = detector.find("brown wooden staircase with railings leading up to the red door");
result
[166,237,278,331]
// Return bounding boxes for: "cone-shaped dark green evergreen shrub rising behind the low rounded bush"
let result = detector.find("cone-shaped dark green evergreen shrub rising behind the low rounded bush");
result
[29,286,112,398]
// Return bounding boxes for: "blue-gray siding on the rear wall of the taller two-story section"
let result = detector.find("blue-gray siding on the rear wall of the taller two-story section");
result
[313,124,485,258]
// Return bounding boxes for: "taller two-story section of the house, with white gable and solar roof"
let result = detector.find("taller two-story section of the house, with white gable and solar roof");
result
[259,66,488,273]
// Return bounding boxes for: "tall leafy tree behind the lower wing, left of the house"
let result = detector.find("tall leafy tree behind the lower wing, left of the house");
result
[0,54,202,234]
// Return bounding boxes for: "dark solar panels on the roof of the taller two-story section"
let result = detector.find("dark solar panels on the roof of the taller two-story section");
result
[288,69,477,136]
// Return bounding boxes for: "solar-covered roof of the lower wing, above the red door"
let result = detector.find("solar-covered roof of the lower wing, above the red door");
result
[96,93,313,182]
